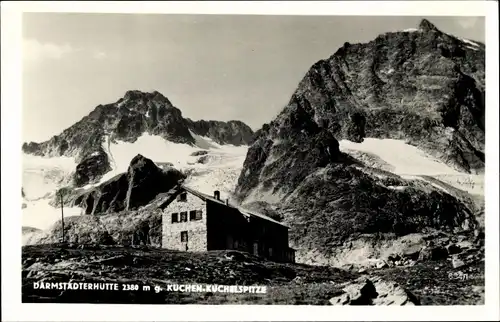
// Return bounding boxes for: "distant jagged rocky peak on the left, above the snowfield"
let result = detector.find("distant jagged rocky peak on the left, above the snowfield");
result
[22,91,253,186]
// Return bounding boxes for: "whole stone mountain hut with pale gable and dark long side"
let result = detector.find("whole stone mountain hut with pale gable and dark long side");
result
[161,186,295,262]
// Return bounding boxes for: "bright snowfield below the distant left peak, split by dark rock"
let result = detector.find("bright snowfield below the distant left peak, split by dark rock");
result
[22,133,248,235]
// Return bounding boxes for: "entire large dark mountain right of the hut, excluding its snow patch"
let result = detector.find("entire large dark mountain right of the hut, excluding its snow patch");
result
[236,20,484,263]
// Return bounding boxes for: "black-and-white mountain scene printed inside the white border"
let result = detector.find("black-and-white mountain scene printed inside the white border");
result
[2,1,498,319]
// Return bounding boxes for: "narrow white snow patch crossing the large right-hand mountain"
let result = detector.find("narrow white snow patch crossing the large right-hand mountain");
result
[339,138,484,195]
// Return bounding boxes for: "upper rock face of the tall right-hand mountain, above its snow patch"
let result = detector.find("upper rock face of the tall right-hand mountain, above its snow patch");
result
[246,20,485,176]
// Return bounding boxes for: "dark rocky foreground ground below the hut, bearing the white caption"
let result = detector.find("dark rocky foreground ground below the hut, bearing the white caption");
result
[22,244,484,305]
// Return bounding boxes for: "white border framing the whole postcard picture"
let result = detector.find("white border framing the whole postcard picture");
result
[1,1,500,321]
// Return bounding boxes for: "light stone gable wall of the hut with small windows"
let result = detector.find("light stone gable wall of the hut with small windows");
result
[162,193,207,251]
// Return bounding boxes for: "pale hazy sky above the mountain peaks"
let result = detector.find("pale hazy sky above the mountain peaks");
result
[23,13,485,141]
